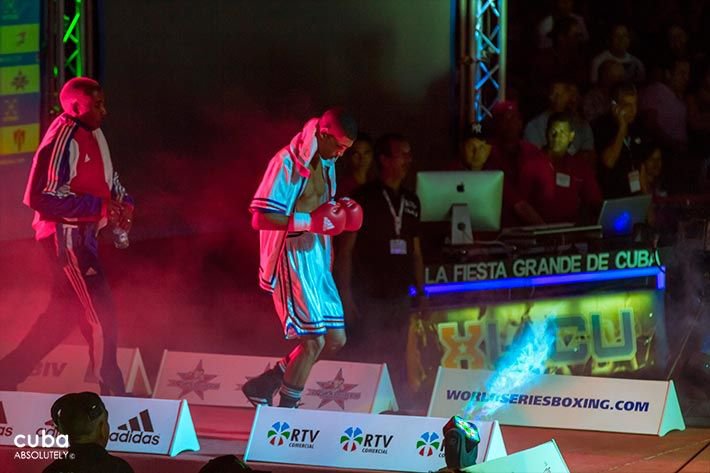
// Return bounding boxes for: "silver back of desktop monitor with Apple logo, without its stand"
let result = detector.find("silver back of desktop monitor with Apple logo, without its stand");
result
[417,171,503,231]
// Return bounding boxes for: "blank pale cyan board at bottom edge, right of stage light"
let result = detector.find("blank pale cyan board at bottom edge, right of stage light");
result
[461,440,569,473]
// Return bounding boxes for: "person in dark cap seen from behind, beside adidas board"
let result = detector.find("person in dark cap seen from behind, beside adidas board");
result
[44,392,133,473]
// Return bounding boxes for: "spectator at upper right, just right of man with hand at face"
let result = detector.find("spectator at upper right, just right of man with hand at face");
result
[639,59,690,153]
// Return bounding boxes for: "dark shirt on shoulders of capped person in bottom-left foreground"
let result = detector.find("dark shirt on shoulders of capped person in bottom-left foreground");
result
[44,443,134,473]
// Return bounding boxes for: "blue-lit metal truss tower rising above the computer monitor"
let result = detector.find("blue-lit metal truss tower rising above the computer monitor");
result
[456,0,508,128]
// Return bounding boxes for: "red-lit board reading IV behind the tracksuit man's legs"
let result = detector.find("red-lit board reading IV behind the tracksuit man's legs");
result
[17,345,152,397]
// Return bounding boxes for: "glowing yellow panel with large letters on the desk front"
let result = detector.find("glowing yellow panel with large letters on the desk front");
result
[432,290,668,376]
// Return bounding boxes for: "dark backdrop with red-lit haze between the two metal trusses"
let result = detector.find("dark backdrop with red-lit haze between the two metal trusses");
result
[101,0,451,237]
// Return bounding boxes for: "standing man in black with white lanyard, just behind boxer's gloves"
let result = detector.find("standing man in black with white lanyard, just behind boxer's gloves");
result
[335,134,424,399]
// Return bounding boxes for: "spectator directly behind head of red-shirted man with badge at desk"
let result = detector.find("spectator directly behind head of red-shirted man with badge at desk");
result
[524,79,594,163]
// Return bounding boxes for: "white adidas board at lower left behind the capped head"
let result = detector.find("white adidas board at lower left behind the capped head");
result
[0,391,200,456]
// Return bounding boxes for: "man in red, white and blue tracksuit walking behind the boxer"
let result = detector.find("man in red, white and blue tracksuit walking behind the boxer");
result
[0,77,133,395]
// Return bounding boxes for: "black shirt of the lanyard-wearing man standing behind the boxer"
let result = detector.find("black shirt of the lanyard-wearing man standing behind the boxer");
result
[351,180,421,299]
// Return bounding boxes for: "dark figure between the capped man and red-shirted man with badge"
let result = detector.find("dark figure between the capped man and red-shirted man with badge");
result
[486,101,544,227]
